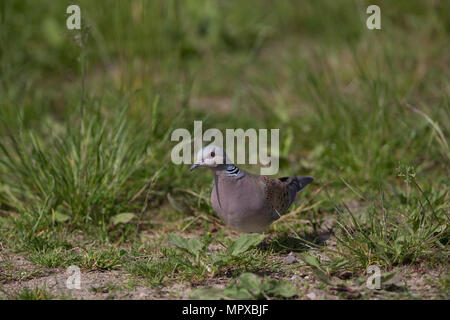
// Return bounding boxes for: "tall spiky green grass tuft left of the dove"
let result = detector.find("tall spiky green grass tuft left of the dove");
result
[0,104,149,225]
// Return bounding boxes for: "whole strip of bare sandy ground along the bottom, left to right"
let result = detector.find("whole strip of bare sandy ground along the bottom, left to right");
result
[0,245,450,300]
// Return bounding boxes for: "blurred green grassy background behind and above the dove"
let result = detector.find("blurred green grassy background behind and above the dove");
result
[0,0,450,241]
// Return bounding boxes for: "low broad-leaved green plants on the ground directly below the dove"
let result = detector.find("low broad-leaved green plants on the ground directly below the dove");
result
[125,233,280,287]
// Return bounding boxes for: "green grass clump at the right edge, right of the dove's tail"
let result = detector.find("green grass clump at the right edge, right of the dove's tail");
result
[331,174,450,270]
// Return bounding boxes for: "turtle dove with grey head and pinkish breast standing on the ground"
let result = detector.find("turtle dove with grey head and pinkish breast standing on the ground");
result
[190,145,314,233]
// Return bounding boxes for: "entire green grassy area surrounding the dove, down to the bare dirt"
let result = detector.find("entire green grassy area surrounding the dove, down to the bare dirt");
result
[0,0,450,298]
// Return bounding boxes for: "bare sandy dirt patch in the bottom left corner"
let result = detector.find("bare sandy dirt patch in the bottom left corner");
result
[0,251,190,300]
